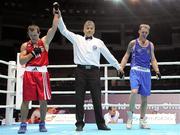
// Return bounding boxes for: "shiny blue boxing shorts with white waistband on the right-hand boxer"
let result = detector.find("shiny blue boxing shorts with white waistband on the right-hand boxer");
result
[130,66,151,96]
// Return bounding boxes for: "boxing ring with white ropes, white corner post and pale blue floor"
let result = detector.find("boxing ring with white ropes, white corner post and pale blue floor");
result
[0,60,180,135]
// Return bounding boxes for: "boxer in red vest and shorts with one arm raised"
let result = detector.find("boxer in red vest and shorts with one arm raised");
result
[18,3,60,134]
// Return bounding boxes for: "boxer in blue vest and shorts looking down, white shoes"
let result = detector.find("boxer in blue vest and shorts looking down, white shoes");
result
[120,24,161,129]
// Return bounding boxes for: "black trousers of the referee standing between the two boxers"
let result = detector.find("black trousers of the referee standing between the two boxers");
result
[75,65,105,127]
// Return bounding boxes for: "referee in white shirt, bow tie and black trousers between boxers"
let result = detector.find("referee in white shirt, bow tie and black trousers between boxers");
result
[58,9,120,131]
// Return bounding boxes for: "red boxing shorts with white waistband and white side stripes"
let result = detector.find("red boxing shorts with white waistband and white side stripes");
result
[23,66,51,101]
